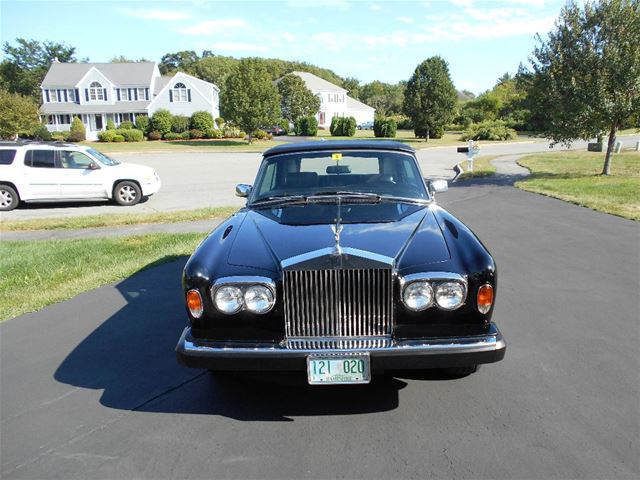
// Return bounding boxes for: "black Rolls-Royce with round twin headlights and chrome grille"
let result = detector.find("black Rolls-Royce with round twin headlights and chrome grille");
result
[176,140,506,384]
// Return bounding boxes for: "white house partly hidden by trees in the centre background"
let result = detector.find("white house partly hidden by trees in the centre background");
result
[291,72,376,128]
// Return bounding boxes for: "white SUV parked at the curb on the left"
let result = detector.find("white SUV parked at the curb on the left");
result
[0,141,160,211]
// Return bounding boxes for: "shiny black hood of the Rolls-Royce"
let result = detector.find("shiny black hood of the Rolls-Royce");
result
[228,203,450,271]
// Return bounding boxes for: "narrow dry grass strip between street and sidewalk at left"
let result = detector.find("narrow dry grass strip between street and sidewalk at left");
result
[0,207,239,232]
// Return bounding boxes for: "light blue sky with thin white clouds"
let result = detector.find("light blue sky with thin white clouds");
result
[0,0,565,94]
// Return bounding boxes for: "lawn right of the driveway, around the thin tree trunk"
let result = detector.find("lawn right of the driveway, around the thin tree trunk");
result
[516,152,640,220]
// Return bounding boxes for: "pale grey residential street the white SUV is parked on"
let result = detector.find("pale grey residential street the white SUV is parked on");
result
[0,137,640,220]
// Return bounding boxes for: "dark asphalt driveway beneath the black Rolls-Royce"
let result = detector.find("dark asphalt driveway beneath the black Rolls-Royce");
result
[0,178,640,479]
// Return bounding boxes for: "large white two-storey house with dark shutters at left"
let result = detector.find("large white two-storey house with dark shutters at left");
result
[40,62,220,140]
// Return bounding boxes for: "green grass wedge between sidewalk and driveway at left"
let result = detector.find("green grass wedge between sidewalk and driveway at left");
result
[0,233,205,321]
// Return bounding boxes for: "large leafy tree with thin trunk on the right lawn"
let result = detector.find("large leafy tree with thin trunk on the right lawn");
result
[529,0,640,175]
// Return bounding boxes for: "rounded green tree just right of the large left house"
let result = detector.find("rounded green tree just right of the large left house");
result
[221,58,282,143]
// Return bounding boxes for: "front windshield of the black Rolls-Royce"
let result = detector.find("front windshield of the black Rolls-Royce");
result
[251,151,429,203]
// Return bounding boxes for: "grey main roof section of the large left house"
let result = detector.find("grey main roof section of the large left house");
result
[42,62,156,88]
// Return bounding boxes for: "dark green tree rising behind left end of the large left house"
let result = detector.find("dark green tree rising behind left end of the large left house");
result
[0,38,76,98]
